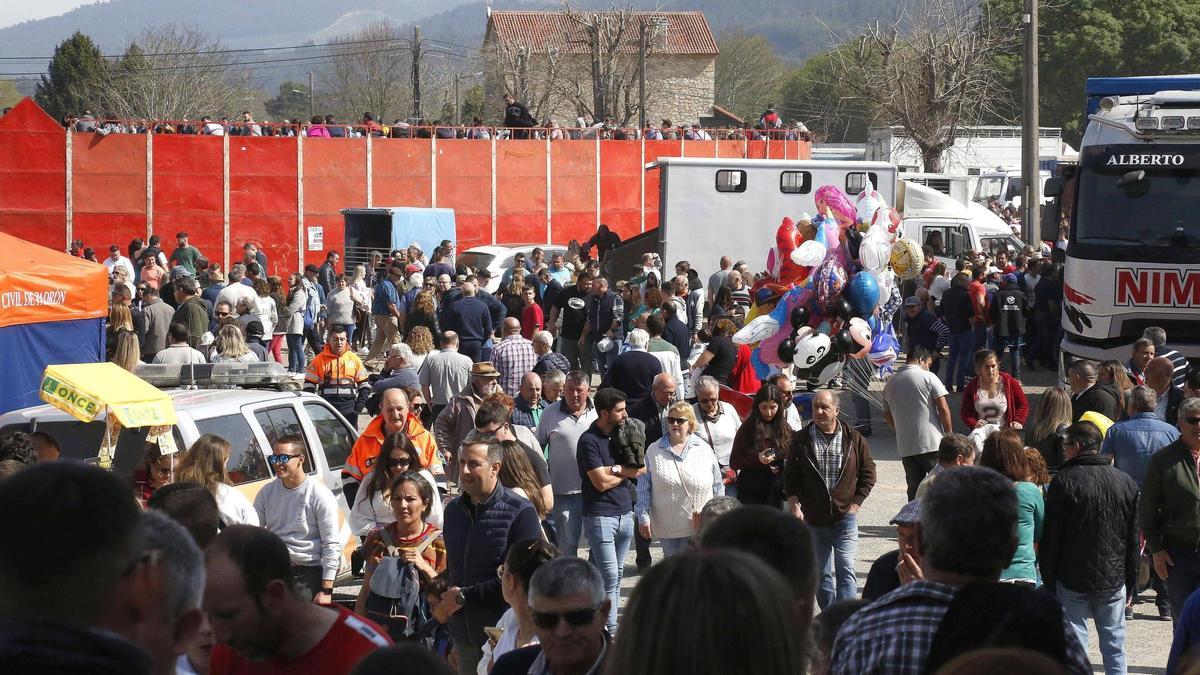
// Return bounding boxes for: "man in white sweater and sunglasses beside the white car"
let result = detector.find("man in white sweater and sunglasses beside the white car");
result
[254,436,342,604]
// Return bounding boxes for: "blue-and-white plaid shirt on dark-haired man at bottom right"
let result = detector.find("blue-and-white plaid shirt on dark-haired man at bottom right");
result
[829,581,1092,675]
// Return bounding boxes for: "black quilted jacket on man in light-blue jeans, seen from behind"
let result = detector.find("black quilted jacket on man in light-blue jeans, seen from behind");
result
[1038,453,1140,593]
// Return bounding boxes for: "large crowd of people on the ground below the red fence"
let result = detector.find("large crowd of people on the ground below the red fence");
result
[7,228,1200,675]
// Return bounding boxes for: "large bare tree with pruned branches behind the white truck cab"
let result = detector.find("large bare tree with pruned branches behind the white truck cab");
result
[830,0,1019,172]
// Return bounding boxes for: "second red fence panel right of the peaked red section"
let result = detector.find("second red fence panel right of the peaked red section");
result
[152,135,225,271]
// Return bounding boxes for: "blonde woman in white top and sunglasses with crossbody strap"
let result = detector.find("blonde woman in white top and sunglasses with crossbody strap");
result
[634,401,725,556]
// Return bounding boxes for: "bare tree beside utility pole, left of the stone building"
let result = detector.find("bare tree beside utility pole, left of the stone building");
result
[317,22,413,121]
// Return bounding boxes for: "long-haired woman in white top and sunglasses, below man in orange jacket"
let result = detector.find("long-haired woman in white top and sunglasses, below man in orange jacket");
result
[350,432,442,533]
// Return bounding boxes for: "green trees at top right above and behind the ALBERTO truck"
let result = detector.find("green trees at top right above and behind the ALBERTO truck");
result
[986,0,1200,144]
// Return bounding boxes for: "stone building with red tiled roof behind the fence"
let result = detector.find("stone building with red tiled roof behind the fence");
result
[484,11,718,126]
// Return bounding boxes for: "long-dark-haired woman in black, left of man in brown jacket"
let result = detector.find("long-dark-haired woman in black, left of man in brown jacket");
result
[730,383,792,507]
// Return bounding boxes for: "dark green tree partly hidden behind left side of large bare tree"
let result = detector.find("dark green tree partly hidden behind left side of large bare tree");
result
[775,47,871,143]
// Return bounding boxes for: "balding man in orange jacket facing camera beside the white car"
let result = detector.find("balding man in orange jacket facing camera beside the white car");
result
[342,388,445,503]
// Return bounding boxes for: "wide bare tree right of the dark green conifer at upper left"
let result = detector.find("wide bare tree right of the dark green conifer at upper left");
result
[92,24,253,120]
